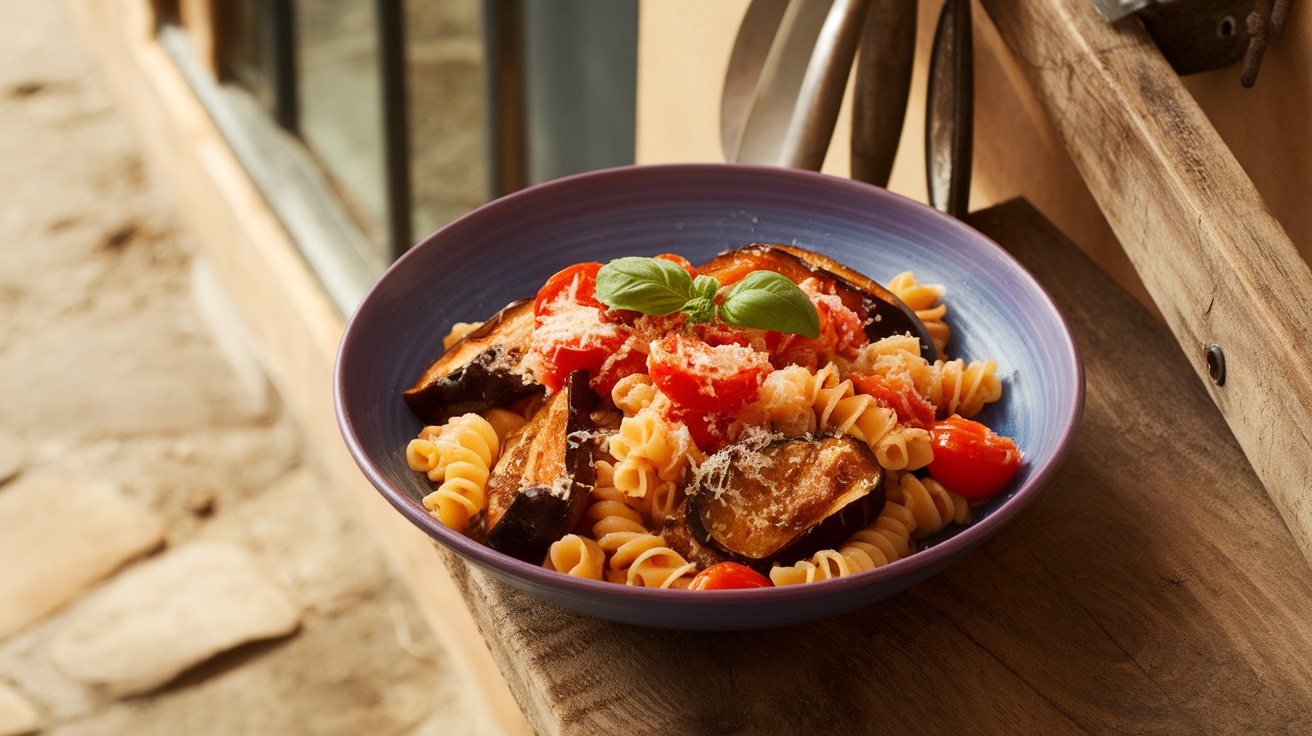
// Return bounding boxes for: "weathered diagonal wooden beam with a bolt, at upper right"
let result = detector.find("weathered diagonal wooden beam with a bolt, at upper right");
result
[984,0,1312,569]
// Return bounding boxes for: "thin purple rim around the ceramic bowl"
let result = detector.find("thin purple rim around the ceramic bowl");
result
[332,163,1085,609]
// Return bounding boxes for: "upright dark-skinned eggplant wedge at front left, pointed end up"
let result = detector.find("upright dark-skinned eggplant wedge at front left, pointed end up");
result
[480,370,601,564]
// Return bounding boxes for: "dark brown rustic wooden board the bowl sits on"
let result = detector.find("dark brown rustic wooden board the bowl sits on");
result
[450,196,1312,735]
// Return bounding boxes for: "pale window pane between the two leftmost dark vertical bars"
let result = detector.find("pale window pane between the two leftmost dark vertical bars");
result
[294,0,387,253]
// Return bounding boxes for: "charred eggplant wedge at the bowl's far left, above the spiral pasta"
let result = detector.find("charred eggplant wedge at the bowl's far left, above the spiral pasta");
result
[403,299,539,424]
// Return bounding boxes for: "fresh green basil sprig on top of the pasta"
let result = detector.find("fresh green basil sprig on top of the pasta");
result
[597,256,820,337]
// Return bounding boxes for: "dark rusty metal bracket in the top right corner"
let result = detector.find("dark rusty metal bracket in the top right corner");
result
[1093,0,1290,87]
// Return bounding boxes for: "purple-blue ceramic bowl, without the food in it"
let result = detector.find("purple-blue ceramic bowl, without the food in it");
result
[335,164,1084,630]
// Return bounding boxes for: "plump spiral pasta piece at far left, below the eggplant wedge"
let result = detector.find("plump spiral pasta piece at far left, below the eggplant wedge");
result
[405,413,501,531]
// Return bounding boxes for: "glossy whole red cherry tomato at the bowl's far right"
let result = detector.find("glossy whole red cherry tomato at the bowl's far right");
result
[929,415,1021,499]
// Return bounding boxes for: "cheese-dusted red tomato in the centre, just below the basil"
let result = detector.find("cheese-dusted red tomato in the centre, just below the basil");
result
[647,332,771,415]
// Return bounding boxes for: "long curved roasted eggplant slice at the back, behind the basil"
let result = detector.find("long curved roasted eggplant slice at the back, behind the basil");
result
[697,244,938,362]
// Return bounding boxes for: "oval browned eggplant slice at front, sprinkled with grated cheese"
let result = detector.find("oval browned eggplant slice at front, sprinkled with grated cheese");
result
[687,436,884,571]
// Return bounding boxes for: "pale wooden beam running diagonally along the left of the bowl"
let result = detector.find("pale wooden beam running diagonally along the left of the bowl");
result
[55,0,529,735]
